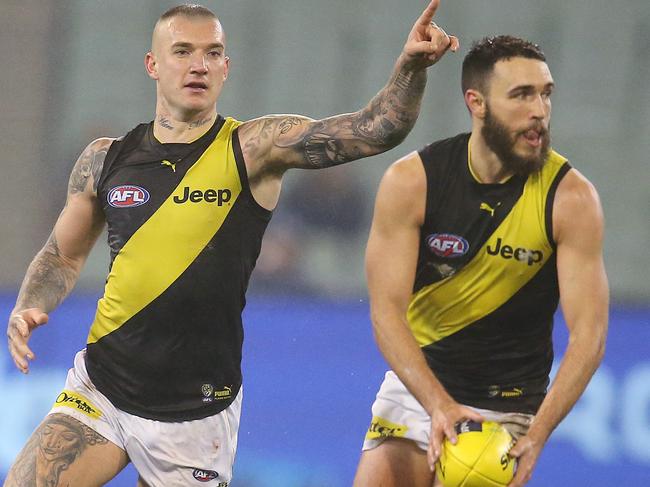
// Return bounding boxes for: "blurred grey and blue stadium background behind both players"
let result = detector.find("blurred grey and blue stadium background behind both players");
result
[0,0,650,487]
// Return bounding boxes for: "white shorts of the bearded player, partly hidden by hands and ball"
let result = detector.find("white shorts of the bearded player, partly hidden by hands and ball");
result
[363,371,534,450]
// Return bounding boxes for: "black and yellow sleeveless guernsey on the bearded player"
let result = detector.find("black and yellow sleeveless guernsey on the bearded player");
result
[407,134,570,413]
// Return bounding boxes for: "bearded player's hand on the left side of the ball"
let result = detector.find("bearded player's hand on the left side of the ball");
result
[427,398,485,472]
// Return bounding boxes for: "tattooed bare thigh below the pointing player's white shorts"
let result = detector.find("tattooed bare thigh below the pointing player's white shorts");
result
[7,414,108,487]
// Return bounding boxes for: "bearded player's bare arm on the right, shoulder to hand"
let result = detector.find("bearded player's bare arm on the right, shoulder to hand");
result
[510,170,609,487]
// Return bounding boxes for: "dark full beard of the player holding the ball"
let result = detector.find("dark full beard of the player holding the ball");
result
[481,105,551,177]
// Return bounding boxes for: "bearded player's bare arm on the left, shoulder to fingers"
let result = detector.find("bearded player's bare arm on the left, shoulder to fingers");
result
[366,153,483,468]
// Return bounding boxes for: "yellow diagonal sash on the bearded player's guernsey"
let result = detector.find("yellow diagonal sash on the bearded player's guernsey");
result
[407,151,567,347]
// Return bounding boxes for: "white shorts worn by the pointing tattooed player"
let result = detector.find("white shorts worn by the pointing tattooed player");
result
[48,350,242,487]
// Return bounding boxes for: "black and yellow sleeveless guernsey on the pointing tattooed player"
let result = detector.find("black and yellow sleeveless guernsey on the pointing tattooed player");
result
[86,117,271,421]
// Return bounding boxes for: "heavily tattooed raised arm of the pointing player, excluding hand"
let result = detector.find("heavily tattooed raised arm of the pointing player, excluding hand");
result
[282,61,426,168]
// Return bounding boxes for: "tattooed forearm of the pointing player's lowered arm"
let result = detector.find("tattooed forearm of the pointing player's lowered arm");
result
[17,232,79,312]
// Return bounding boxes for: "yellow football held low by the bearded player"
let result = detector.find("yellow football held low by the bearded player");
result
[436,421,516,487]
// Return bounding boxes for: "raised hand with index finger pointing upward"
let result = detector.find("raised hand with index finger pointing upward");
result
[404,0,460,67]
